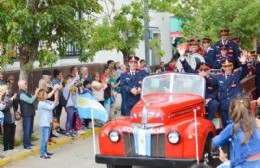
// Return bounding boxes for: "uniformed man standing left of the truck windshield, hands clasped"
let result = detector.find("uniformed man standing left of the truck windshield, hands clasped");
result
[120,56,147,116]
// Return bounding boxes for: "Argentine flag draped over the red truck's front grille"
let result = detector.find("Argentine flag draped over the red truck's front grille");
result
[134,127,152,156]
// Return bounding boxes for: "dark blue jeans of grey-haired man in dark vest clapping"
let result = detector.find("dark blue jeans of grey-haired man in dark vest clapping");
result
[23,116,34,148]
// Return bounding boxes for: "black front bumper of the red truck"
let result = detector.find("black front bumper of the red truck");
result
[95,154,196,168]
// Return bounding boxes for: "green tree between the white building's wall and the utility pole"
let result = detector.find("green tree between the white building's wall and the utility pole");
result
[81,0,164,62]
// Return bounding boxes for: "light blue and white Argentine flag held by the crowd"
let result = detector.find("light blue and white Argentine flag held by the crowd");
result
[77,93,108,122]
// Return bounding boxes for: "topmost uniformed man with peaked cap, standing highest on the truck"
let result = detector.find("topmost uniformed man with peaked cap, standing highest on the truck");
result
[213,29,241,68]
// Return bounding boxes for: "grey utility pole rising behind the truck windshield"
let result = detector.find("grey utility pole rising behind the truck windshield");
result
[144,0,151,65]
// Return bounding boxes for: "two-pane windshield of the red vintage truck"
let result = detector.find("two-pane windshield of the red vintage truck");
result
[141,73,205,98]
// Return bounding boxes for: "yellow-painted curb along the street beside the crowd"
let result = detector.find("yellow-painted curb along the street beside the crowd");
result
[0,128,100,167]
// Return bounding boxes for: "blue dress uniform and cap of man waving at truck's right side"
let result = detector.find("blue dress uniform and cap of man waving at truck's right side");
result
[214,60,248,127]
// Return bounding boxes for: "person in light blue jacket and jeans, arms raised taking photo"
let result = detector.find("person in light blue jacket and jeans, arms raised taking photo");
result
[37,89,58,159]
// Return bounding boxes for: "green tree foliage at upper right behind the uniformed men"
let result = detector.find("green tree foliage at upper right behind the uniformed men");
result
[162,0,260,49]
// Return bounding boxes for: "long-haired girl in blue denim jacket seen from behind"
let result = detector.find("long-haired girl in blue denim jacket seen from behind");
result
[212,96,260,168]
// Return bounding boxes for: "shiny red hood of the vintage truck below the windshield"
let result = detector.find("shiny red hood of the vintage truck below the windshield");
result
[130,93,204,124]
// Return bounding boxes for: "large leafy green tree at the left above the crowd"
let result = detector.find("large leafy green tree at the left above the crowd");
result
[0,0,102,79]
